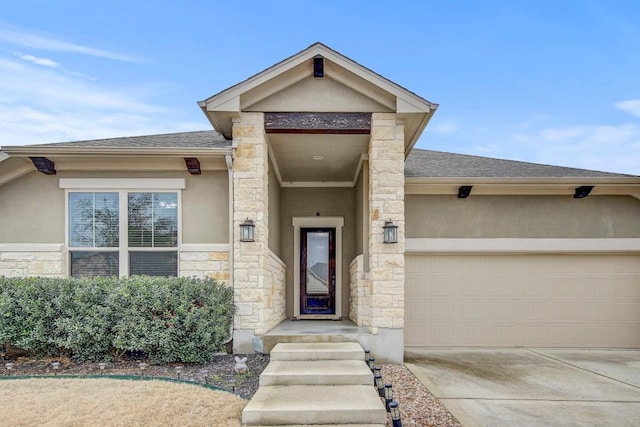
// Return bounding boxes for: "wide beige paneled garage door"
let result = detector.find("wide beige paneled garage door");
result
[405,255,640,348]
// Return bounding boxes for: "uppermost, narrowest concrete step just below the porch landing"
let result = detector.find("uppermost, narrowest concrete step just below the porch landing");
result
[271,342,364,361]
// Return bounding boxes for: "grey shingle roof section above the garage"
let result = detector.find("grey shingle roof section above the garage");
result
[404,148,633,178]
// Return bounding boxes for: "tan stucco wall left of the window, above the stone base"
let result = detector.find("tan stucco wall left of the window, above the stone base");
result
[0,172,64,243]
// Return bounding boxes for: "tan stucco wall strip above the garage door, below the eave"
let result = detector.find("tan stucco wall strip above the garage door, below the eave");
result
[406,195,640,238]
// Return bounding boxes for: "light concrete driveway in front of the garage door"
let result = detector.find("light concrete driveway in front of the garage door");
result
[405,349,640,427]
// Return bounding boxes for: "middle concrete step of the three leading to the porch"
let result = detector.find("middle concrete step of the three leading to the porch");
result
[260,360,373,386]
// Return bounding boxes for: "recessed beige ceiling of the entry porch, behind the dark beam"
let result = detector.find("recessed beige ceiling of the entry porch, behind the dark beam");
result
[268,134,370,186]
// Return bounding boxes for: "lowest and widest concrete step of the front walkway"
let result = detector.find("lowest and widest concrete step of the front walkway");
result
[242,385,387,427]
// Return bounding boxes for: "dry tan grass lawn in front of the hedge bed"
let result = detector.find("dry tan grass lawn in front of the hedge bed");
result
[0,378,247,427]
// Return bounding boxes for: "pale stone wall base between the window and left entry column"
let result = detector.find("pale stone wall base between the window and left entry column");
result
[179,250,230,283]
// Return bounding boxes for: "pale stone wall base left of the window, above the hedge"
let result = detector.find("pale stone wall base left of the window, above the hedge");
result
[0,244,66,277]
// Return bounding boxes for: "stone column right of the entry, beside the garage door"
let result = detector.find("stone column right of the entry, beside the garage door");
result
[369,113,405,362]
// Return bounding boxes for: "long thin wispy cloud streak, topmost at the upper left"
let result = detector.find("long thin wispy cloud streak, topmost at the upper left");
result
[0,22,140,62]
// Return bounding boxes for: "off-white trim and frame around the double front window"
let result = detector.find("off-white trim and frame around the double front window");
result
[60,186,185,277]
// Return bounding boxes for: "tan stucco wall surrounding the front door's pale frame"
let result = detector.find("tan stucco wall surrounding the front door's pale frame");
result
[280,187,356,318]
